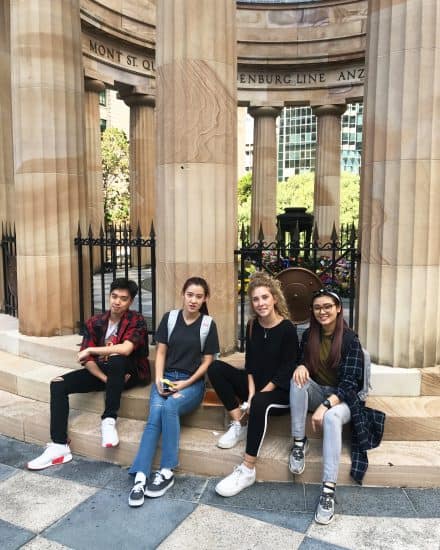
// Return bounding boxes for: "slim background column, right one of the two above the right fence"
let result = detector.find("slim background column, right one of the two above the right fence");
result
[313,105,347,244]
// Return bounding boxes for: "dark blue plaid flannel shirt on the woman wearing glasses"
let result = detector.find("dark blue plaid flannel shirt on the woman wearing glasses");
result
[298,329,385,484]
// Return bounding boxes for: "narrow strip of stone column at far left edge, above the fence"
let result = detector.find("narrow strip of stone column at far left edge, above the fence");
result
[0,2,15,311]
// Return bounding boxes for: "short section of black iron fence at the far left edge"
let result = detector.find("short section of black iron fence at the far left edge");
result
[1,223,18,317]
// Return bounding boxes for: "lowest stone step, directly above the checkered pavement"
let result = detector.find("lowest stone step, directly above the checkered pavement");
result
[0,391,440,487]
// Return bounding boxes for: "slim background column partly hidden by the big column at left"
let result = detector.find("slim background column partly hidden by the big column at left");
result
[84,78,105,239]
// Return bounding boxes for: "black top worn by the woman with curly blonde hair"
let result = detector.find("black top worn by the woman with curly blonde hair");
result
[245,319,298,391]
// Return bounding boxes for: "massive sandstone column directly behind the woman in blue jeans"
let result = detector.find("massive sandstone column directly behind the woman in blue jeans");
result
[156,0,237,350]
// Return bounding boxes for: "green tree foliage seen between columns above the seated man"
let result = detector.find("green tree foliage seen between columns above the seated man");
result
[101,128,130,224]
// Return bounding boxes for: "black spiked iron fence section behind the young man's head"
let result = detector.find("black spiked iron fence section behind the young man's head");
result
[74,223,156,335]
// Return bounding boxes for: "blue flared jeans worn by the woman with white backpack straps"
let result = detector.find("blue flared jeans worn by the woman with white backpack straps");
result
[129,371,205,477]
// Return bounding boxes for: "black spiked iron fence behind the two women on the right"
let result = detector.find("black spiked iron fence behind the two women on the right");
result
[234,225,360,351]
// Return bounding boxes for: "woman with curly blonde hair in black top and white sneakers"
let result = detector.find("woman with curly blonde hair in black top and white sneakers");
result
[208,273,298,497]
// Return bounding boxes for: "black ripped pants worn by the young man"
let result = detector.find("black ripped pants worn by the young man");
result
[50,355,139,444]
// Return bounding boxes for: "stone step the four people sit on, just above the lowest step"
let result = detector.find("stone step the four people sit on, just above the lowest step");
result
[0,352,440,441]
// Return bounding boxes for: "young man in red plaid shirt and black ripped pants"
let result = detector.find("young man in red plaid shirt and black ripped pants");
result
[27,279,150,470]
